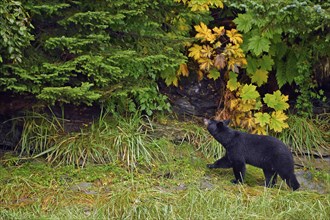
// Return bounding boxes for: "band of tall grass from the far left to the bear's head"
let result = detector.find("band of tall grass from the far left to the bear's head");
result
[11,112,223,169]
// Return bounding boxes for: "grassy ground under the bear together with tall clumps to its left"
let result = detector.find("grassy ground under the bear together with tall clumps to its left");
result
[0,112,330,220]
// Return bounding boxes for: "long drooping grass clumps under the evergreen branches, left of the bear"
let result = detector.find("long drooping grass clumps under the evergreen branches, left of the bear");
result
[19,113,166,167]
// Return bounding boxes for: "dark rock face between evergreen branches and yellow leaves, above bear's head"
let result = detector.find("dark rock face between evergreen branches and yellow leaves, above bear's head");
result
[159,78,225,117]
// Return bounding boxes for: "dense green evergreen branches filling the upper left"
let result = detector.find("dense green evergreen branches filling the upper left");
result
[0,0,201,114]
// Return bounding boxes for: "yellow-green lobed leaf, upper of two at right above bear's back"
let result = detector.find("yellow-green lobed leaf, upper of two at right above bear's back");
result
[263,90,290,111]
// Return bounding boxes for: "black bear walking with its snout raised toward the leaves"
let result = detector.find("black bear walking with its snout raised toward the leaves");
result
[204,119,300,190]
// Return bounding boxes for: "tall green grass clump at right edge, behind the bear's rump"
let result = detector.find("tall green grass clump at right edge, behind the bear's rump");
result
[278,114,330,157]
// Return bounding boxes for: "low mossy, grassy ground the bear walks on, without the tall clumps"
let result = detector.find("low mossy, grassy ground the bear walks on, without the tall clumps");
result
[0,117,330,220]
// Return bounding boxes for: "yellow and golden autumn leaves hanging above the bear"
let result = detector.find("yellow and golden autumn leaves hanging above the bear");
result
[172,1,289,134]
